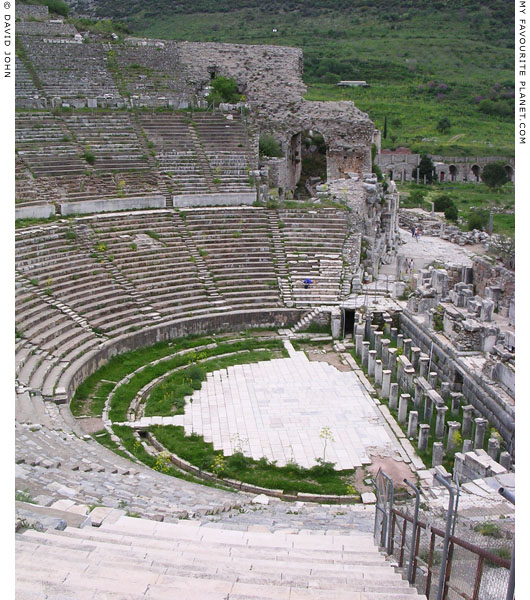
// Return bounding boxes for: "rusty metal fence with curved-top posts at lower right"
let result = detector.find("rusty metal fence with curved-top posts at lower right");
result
[374,471,515,600]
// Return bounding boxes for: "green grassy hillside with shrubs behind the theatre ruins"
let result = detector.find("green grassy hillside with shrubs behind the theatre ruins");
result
[81,0,514,155]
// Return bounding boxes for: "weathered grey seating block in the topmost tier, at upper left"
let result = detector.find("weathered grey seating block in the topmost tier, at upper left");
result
[19,36,124,106]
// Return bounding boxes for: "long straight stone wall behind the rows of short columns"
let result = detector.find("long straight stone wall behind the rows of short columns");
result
[399,313,515,447]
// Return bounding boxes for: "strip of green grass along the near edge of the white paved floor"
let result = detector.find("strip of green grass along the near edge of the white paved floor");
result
[150,426,356,495]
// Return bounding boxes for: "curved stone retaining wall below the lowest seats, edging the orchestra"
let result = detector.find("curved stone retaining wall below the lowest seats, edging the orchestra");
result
[60,308,304,402]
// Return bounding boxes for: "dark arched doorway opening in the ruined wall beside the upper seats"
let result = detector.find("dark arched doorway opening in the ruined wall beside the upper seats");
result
[293,129,328,199]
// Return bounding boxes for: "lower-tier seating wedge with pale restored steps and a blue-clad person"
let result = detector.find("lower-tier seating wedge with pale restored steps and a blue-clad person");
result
[279,209,347,306]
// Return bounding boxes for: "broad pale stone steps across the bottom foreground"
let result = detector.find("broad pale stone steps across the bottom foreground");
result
[15,506,425,600]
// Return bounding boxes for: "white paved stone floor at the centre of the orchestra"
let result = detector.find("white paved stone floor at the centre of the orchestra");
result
[184,352,395,469]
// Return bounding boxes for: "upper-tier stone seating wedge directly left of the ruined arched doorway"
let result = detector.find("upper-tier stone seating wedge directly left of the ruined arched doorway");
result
[193,113,253,192]
